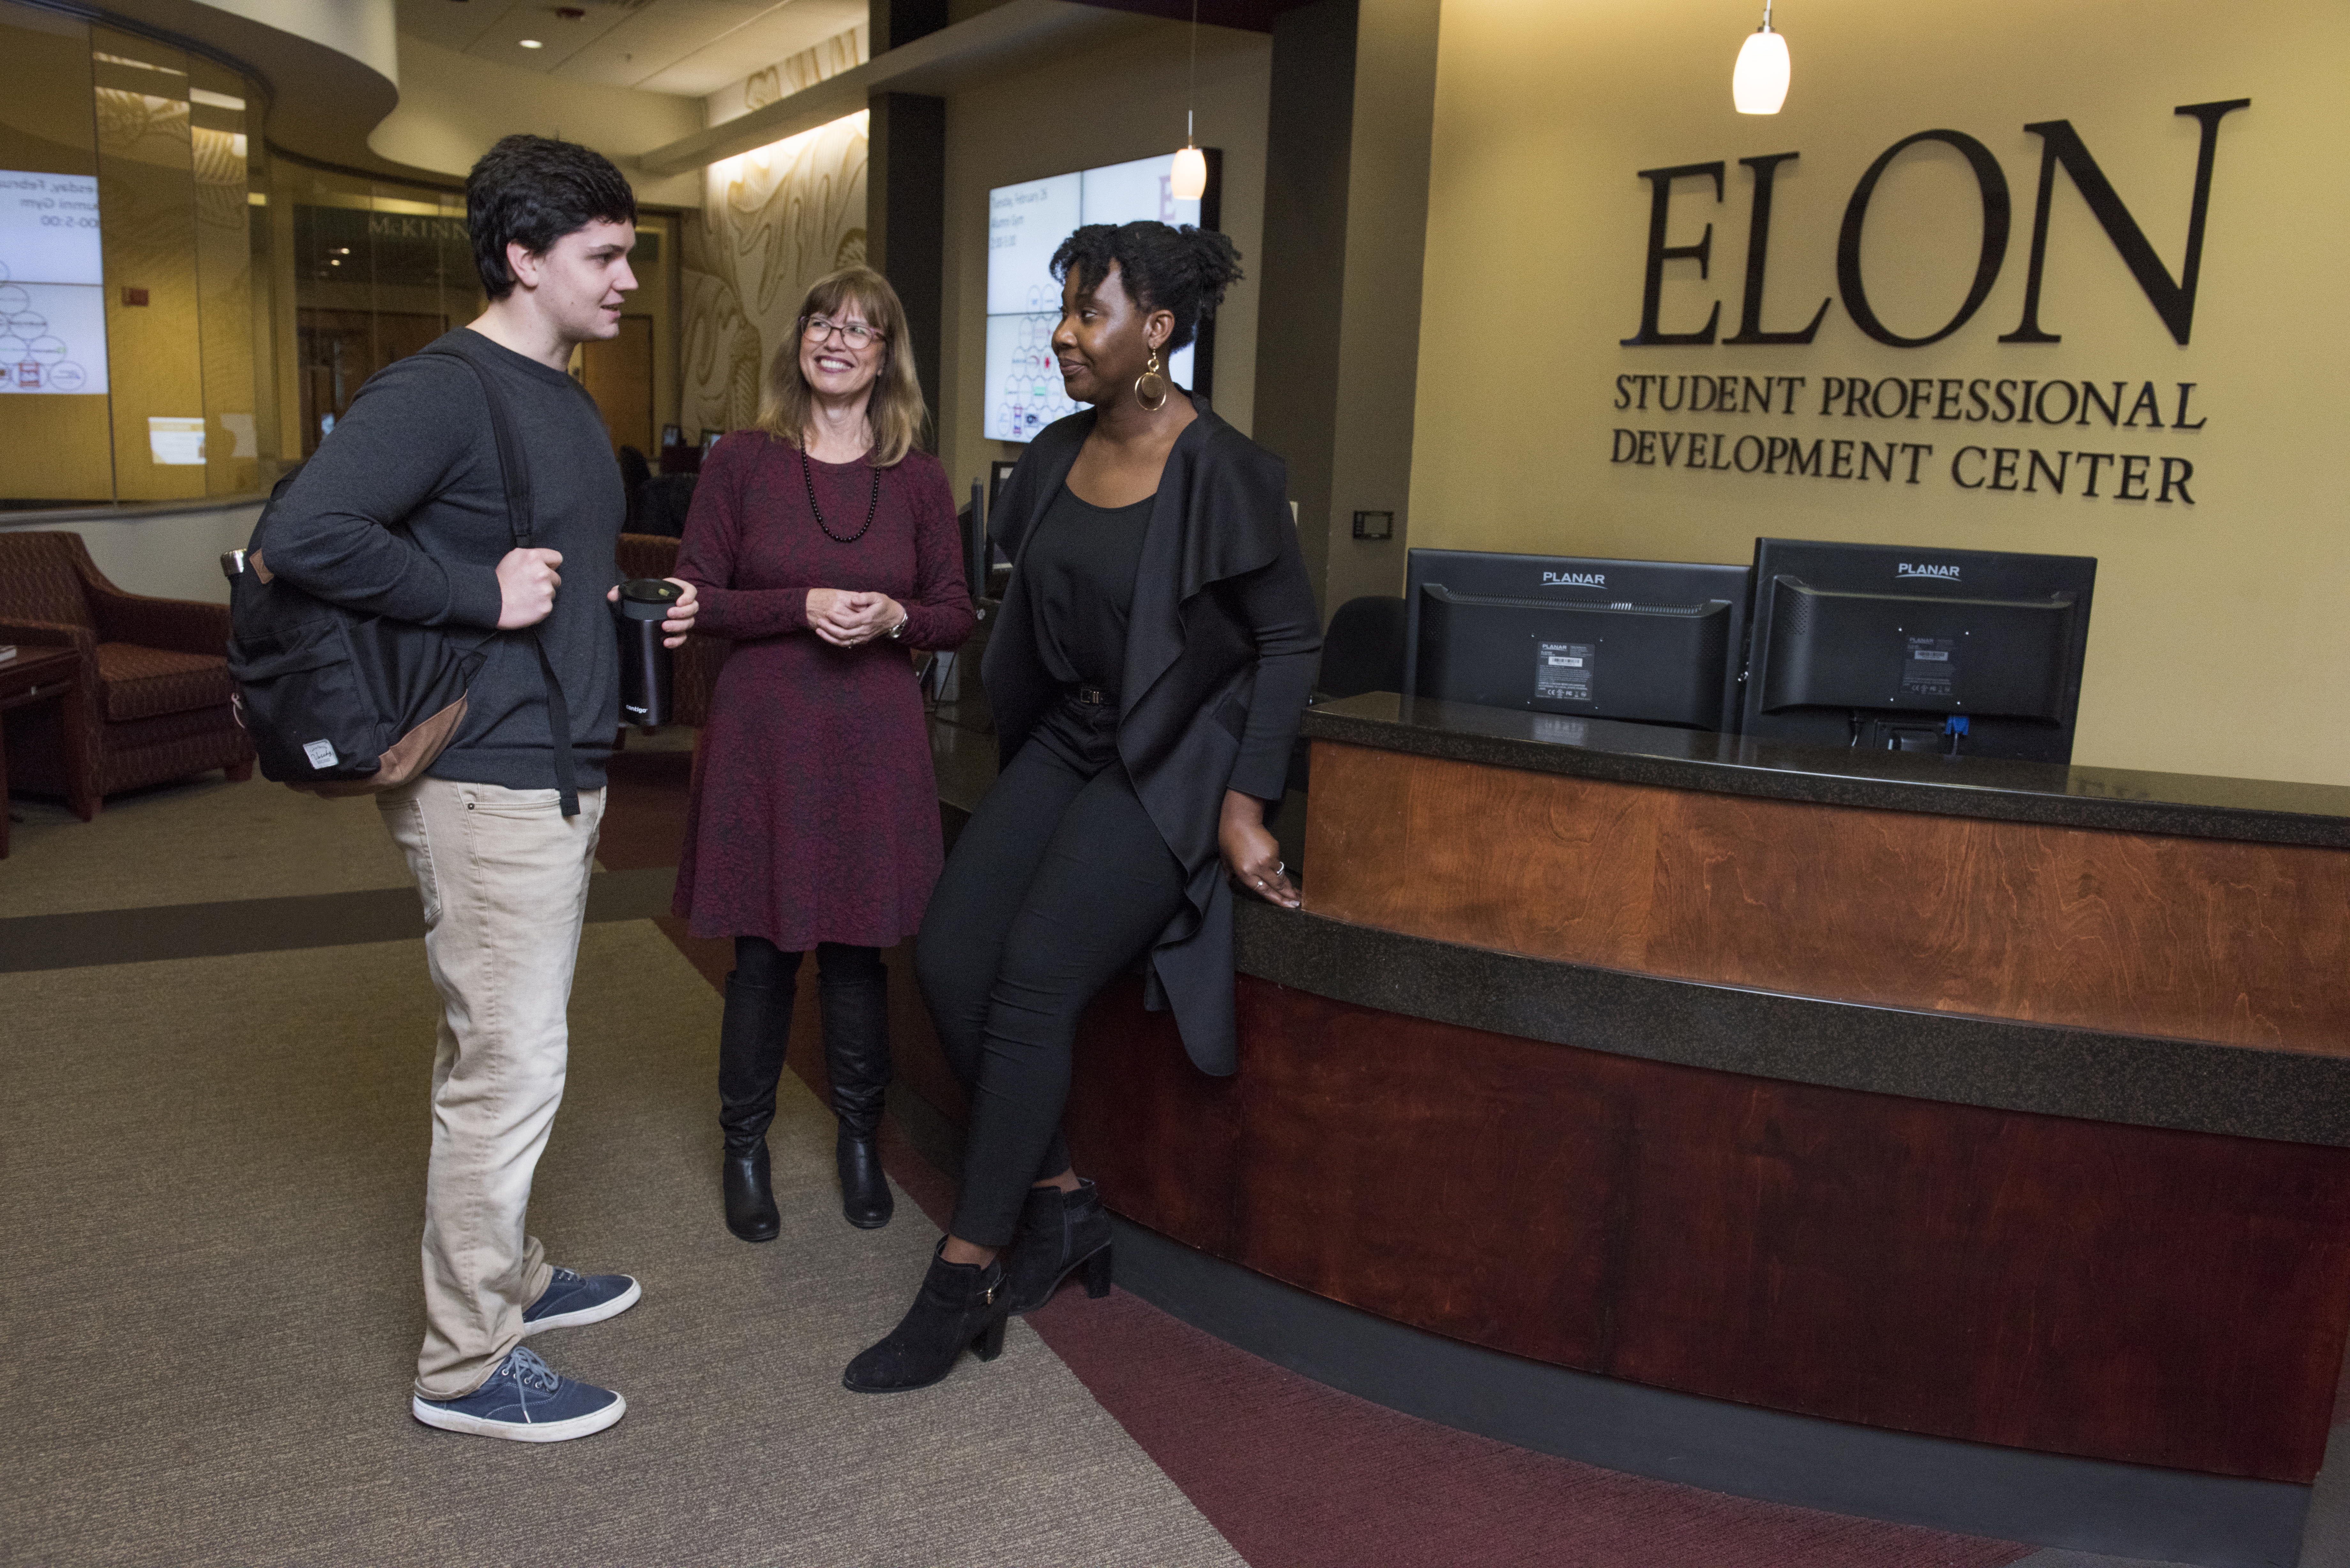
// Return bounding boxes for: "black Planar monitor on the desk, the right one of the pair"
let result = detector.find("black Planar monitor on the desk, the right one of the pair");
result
[1739,538,2096,762]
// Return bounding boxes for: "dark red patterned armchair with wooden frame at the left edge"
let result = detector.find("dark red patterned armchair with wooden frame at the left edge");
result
[0,529,254,820]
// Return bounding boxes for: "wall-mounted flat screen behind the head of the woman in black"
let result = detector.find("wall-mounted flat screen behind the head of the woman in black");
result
[982,153,1213,442]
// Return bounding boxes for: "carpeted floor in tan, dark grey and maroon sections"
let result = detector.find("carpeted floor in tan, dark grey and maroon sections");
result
[0,752,2256,1568]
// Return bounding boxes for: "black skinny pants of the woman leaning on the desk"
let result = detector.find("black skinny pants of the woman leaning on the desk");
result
[914,701,1184,1246]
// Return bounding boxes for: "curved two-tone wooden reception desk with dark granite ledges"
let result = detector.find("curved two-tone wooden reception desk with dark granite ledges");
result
[907,693,2350,1563]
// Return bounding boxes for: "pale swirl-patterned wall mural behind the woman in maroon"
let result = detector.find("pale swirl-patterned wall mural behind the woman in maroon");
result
[679,28,867,433]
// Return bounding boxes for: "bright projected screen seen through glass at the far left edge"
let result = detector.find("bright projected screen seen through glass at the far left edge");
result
[0,169,106,397]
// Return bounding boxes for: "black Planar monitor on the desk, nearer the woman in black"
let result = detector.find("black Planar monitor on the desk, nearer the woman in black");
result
[1403,550,1748,729]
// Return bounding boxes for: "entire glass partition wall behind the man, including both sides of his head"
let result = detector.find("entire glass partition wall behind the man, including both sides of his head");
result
[0,0,677,512]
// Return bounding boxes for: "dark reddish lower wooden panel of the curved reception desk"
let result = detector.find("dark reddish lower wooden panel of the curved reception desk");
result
[1156,976,2350,1483]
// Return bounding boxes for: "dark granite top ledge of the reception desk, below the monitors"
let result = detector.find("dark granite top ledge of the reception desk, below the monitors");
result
[1302,691,2350,849]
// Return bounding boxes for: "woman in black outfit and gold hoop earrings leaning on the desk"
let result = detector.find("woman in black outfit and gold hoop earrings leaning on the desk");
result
[841,223,1321,1394]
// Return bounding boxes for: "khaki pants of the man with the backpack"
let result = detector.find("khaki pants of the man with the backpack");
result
[376,778,604,1399]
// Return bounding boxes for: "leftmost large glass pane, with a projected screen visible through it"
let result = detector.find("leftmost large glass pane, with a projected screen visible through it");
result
[0,0,280,508]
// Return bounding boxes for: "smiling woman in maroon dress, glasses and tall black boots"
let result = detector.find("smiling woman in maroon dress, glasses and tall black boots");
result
[677,268,975,1241]
